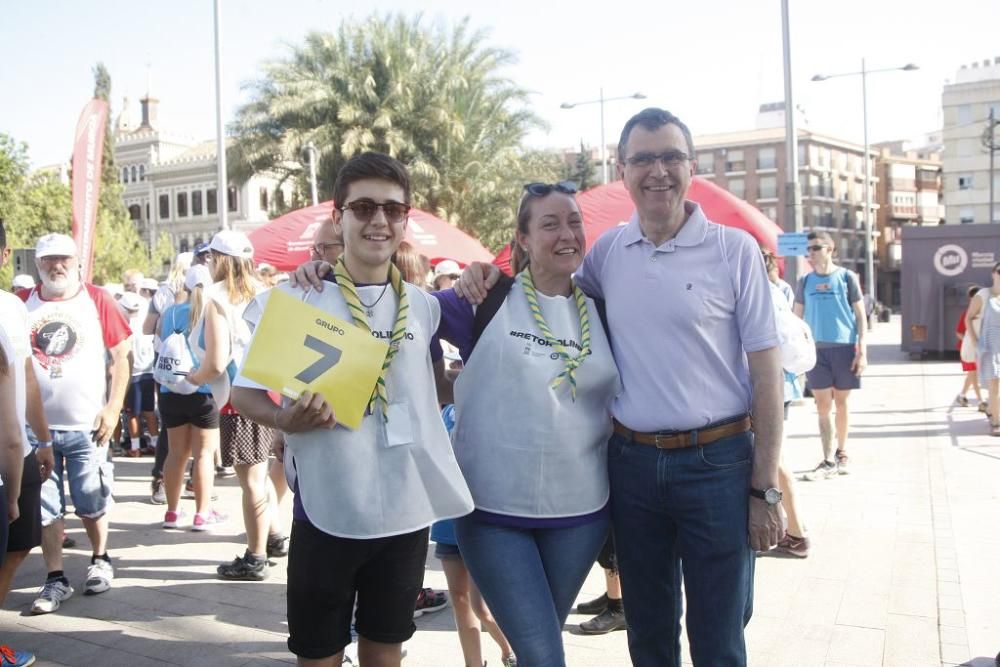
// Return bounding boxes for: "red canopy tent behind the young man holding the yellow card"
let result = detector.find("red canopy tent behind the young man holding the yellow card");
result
[250,200,493,271]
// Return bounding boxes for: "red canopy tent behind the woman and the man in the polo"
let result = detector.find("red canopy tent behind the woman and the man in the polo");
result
[493,176,781,273]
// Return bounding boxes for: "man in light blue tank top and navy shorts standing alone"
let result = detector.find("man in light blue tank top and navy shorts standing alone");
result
[794,231,868,480]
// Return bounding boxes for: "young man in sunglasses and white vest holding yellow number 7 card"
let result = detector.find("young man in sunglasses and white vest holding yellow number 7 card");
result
[233,153,472,667]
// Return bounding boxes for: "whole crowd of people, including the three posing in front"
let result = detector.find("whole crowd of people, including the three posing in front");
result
[0,108,876,667]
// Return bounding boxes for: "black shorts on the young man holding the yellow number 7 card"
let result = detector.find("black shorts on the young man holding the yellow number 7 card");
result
[288,520,429,660]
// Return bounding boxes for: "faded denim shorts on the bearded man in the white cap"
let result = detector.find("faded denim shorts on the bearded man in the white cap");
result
[35,431,115,526]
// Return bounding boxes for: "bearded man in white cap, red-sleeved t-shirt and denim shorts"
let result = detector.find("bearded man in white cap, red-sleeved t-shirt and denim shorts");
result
[18,234,132,614]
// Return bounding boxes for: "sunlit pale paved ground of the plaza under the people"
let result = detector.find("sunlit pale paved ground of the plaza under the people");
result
[0,319,1000,667]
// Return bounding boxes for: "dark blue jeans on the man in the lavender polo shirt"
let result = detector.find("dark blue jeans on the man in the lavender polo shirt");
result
[608,432,754,667]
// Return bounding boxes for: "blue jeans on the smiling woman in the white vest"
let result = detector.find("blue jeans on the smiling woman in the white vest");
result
[455,515,608,667]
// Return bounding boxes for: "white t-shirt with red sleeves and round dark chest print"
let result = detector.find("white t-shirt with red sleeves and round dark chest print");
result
[18,284,132,431]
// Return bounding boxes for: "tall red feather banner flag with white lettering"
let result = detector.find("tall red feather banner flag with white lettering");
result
[72,99,108,283]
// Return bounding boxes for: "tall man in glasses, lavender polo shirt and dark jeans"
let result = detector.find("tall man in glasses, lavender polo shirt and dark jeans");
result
[456,109,782,667]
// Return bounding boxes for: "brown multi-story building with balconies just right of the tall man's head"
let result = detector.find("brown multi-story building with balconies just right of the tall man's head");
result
[694,103,878,276]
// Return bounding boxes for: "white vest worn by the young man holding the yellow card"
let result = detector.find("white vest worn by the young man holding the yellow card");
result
[274,284,473,539]
